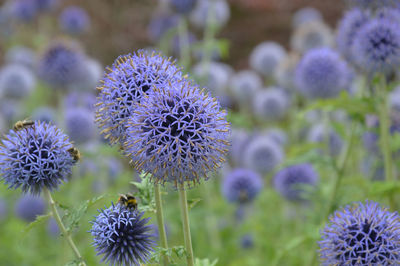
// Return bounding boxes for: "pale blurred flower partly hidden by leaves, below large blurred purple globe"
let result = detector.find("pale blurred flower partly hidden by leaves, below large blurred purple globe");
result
[307,124,343,156]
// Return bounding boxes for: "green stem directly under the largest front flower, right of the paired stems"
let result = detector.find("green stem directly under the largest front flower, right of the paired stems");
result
[179,185,194,266]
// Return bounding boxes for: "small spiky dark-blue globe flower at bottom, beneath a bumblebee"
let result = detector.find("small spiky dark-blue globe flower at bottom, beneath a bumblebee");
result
[90,204,155,265]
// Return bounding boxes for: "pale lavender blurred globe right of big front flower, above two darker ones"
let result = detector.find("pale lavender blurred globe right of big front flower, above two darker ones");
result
[243,136,284,174]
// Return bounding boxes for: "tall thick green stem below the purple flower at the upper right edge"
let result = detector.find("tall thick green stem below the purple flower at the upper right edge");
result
[377,77,396,210]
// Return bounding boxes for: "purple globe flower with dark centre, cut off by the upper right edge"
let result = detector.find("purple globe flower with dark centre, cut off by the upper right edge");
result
[352,18,400,74]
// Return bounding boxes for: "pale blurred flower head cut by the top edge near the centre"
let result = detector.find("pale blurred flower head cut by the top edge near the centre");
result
[189,0,231,29]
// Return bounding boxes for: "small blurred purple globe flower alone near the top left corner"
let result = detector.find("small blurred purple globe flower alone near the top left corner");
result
[59,6,90,34]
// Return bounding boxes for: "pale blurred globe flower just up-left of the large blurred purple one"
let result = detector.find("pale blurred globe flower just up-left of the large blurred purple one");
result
[249,42,286,77]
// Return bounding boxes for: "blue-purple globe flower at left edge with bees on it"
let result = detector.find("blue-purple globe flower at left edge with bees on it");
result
[0,121,75,194]
